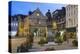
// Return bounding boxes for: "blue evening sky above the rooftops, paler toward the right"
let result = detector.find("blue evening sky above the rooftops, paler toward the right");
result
[11,1,66,15]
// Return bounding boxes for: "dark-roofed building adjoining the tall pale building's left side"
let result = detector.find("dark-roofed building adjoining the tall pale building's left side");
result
[52,7,66,30]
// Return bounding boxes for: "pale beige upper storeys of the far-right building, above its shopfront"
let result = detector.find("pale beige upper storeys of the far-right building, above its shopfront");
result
[66,5,78,30]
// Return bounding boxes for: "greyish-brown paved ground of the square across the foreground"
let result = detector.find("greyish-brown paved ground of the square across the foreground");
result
[29,39,78,52]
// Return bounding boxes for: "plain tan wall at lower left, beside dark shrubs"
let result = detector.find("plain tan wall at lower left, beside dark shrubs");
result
[11,37,26,52]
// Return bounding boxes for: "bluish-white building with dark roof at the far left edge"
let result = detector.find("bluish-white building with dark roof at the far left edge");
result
[9,15,18,37]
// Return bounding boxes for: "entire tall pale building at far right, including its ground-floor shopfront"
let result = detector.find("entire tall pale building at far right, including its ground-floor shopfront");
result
[66,5,78,38]
